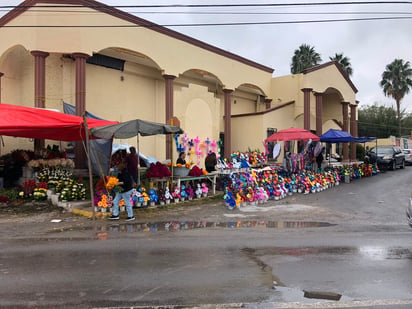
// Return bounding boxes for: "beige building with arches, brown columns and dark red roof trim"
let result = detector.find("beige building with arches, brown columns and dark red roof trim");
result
[0,0,357,166]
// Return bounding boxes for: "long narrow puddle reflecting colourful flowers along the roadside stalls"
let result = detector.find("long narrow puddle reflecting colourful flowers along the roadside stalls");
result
[101,221,334,233]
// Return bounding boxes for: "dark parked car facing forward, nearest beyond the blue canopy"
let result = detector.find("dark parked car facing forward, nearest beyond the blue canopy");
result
[371,146,405,170]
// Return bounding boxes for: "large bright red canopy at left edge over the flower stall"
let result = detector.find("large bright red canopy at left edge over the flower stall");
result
[0,104,117,141]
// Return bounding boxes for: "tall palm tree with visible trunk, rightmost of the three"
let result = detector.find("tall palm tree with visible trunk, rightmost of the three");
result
[380,59,412,137]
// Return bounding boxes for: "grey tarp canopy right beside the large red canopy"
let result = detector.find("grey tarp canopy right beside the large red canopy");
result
[91,119,183,139]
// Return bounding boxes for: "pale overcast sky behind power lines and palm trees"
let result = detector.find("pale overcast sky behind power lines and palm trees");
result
[0,0,412,112]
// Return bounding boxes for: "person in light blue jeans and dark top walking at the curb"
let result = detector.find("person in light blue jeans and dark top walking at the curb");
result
[109,163,135,221]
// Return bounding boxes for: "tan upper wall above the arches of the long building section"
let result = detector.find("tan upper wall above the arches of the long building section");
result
[0,4,272,93]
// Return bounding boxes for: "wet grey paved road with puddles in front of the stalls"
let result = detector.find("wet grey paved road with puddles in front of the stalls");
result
[0,167,412,308]
